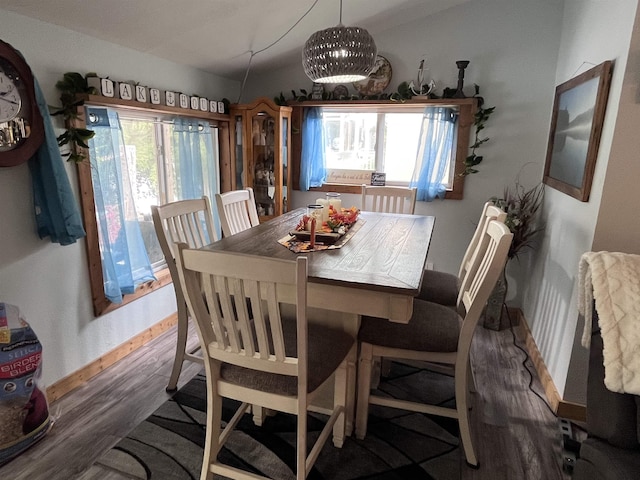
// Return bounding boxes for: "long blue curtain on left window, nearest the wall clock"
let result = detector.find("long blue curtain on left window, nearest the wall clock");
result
[87,108,155,303]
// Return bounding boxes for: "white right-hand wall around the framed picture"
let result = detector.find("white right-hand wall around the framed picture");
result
[523,0,638,402]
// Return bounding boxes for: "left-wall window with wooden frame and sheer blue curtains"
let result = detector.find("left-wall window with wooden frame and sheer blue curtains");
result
[78,99,228,316]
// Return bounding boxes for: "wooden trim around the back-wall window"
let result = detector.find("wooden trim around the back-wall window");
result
[288,97,478,200]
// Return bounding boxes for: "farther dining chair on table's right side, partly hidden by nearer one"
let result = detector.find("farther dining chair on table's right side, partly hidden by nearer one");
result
[416,202,507,307]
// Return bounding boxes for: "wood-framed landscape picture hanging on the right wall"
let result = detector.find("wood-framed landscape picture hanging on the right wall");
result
[543,61,612,202]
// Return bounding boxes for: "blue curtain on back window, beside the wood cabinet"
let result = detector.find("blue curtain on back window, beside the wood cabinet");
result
[300,107,327,191]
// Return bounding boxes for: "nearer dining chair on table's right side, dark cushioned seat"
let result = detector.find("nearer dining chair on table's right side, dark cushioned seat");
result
[356,220,513,467]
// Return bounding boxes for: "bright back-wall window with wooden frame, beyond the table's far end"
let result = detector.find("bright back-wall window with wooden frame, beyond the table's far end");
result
[292,98,476,198]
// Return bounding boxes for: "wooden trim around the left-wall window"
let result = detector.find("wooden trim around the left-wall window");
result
[72,95,231,317]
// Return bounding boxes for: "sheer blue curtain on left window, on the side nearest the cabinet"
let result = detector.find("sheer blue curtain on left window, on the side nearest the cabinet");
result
[172,118,220,241]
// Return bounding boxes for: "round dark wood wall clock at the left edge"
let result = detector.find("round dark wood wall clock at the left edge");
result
[0,40,44,167]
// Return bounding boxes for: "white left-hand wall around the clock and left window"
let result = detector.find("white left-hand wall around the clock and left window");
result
[0,10,239,385]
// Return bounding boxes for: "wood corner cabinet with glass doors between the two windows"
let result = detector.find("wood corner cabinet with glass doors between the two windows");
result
[229,97,292,222]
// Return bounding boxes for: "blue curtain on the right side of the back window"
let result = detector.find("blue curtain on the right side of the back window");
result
[411,107,457,202]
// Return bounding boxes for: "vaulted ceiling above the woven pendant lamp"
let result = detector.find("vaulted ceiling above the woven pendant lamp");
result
[0,0,470,80]
